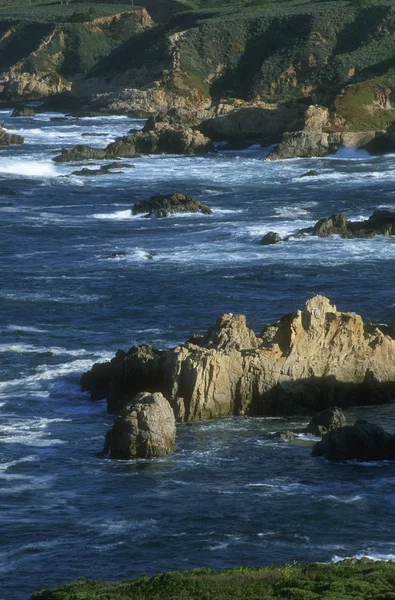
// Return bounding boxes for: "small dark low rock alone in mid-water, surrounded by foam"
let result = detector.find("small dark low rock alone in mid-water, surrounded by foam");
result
[132,193,212,217]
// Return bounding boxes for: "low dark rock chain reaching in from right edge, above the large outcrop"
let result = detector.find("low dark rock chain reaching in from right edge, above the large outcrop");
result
[260,210,395,246]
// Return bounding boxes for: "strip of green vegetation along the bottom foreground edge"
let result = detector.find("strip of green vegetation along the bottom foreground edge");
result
[31,559,395,600]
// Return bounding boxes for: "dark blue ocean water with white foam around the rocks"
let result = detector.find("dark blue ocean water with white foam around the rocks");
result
[0,110,395,600]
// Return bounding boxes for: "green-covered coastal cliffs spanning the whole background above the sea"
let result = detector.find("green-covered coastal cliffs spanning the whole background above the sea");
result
[0,0,395,158]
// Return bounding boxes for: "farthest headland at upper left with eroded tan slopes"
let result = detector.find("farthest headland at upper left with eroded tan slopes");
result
[0,9,153,102]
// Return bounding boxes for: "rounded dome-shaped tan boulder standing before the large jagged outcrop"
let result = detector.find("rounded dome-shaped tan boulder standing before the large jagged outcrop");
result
[104,392,176,459]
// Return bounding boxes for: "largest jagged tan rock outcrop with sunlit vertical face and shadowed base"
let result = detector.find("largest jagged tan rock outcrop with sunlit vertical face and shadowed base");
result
[82,296,395,421]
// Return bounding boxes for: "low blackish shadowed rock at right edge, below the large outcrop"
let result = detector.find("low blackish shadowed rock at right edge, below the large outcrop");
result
[313,420,395,461]
